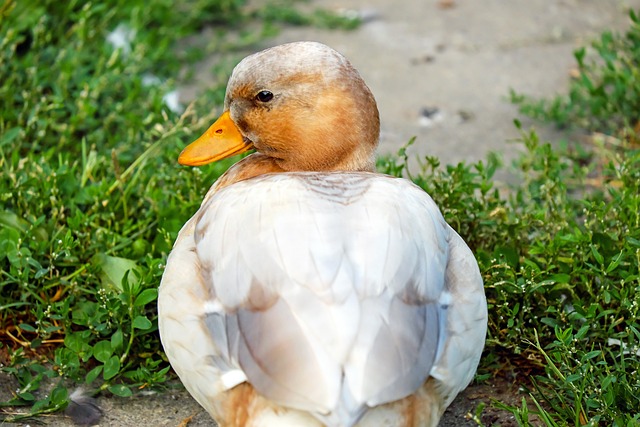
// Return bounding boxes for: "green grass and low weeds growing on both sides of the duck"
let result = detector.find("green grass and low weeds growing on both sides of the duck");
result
[0,0,640,426]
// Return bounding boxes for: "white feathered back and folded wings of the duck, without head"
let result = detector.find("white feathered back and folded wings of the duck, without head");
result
[158,172,487,426]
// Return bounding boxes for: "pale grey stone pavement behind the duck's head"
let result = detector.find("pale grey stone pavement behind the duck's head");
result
[269,0,640,167]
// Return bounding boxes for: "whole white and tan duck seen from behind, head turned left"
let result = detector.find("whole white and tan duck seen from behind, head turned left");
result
[158,42,487,427]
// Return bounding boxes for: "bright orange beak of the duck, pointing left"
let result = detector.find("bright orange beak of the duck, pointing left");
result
[178,111,253,166]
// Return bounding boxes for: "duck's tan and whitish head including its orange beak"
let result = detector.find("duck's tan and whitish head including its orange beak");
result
[178,42,380,171]
